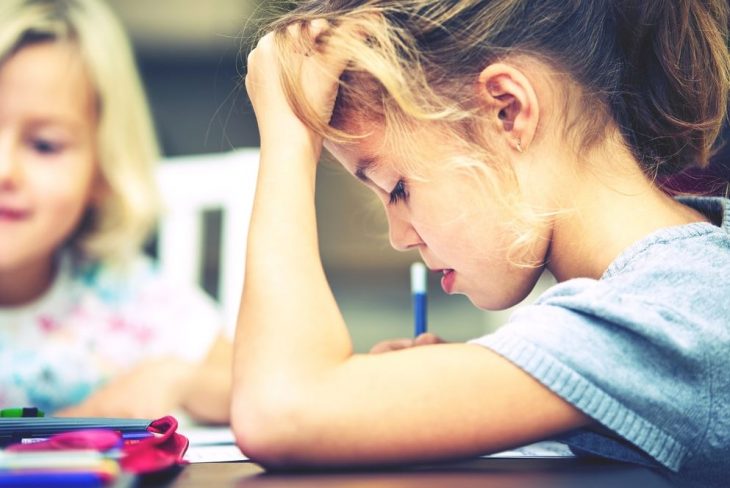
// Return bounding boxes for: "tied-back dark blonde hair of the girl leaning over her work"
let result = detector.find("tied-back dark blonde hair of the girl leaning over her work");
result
[269,0,730,265]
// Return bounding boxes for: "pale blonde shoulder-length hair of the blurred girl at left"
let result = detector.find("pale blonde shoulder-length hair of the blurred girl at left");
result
[0,0,160,262]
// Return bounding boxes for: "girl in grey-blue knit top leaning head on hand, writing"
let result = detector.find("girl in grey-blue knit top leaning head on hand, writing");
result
[237,0,730,483]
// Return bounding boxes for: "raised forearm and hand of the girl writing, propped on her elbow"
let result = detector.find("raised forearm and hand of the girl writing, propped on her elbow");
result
[236,28,352,457]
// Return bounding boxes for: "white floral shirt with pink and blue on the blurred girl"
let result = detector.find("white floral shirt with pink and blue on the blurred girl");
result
[0,254,222,413]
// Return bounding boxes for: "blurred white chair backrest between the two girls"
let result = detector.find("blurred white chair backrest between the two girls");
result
[157,148,259,335]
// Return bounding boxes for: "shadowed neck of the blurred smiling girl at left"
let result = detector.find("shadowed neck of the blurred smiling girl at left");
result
[0,256,56,307]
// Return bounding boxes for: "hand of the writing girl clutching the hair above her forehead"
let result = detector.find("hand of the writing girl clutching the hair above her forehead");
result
[246,20,347,151]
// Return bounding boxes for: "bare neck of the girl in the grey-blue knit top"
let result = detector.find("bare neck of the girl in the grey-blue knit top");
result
[548,140,707,281]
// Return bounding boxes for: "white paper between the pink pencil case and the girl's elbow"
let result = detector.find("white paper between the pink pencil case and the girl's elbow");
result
[178,425,248,463]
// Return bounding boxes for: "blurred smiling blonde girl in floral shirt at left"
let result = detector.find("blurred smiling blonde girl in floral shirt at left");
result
[0,0,231,421]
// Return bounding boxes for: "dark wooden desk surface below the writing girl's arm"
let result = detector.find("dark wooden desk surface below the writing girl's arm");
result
[165,459,672,488]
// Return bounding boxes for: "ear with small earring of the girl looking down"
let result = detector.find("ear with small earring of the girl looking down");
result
[479,63,540,152]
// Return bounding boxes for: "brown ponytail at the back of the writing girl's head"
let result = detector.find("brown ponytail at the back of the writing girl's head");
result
[612,0,730,176]
